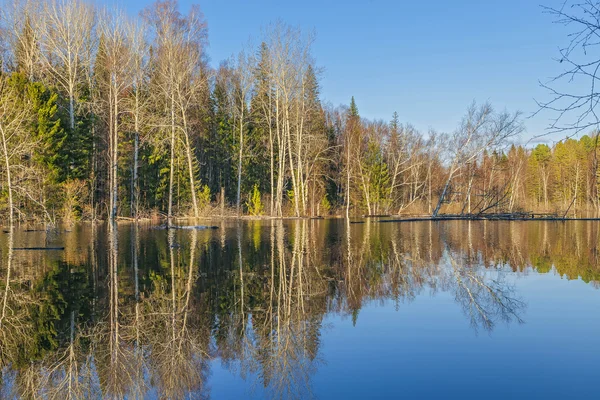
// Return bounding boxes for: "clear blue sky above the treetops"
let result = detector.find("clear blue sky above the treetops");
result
[118,0,580,142]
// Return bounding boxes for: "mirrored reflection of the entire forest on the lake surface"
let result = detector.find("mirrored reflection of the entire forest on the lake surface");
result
[0,220,600,399]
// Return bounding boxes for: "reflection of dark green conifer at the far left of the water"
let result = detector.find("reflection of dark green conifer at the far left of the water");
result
[0,227,97,399]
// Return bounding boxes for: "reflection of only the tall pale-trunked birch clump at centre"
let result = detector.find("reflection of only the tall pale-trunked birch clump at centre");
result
[237,221,325,398]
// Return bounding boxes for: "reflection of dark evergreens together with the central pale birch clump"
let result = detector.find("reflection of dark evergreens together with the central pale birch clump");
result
[209,221,327,398]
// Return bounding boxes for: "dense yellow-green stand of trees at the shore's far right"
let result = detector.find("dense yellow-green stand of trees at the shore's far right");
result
[456,133,600,217]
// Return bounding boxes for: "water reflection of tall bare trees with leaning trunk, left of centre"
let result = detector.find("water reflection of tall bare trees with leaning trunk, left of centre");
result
[142,230,209,399]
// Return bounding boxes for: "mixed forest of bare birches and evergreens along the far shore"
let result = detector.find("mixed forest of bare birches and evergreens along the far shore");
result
[0,0,600,224]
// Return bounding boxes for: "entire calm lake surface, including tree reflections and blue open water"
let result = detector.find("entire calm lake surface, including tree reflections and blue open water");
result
[0,221,600,399]
